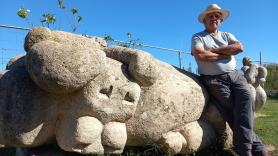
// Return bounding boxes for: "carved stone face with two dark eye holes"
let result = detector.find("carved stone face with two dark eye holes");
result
[80,58,141,123]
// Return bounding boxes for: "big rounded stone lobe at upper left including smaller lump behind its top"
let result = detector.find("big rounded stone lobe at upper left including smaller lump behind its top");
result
[25,27,105,94]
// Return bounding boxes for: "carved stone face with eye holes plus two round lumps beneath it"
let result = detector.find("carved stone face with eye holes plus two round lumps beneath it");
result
[53,58,141,154]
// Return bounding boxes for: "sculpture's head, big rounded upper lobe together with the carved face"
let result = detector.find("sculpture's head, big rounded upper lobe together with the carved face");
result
[25,27,140,123]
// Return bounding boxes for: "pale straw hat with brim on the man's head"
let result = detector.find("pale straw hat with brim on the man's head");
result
[198,4,230,23]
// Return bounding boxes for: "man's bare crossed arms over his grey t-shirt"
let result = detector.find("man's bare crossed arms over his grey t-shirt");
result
[192,41,243,62]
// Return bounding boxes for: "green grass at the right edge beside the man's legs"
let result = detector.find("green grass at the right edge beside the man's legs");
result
[254,98,278,155]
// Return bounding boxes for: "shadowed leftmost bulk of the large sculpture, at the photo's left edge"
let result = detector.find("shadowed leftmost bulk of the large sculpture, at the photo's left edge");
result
[0,63,58,147]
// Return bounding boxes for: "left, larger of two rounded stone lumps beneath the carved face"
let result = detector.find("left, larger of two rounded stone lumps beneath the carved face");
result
[56,116,104,154]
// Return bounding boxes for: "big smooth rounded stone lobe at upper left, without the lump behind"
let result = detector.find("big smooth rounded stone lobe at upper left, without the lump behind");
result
[26,41,105,94]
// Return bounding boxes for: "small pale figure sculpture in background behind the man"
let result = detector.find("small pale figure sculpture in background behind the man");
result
[241,57,267,111]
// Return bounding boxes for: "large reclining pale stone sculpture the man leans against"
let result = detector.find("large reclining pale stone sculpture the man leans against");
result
[0,27,226,154]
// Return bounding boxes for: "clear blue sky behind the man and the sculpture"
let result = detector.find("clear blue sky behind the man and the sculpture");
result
[0,0,278,71]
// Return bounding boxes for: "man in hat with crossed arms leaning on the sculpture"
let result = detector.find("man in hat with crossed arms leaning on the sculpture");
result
[191,4,268,156]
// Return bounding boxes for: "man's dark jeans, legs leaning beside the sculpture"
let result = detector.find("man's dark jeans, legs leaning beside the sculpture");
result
[201,70,264,154]
